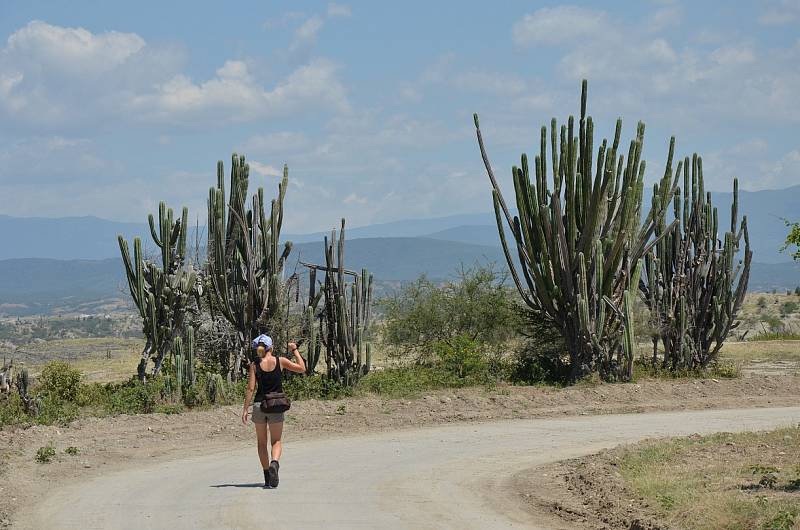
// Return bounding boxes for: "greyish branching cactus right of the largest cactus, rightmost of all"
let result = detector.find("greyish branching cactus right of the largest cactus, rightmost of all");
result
[640,154,753,370]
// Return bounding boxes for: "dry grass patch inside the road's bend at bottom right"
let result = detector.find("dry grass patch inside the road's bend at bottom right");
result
[619,427,800,529]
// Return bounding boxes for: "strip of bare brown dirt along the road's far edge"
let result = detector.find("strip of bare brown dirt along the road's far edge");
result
[0,375,800,525]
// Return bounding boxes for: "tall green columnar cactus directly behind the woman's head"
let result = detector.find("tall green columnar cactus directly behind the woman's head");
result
[208,154,292,377]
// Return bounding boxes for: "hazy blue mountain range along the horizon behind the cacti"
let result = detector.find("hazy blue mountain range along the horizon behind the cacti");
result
[0,186,800,315]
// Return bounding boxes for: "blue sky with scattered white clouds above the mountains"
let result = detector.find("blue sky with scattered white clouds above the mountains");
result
[0,0,800,233]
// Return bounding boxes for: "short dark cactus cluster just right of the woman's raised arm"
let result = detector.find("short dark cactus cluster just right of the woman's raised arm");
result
[303,219,373,385]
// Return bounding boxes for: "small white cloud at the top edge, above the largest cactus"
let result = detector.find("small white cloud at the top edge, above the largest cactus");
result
[512,6,609,47]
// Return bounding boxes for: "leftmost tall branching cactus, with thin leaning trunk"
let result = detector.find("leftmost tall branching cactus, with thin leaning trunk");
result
[117,201,199,380]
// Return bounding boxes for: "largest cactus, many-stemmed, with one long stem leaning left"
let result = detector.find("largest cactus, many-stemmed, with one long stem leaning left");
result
[474,80,677,380]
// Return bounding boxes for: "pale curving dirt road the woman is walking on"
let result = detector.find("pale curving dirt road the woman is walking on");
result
[18,407,800,529]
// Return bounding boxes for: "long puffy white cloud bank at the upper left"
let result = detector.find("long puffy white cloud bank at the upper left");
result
[0,22,349,130]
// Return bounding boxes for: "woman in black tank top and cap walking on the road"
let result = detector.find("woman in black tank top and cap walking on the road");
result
[242,335,306,488]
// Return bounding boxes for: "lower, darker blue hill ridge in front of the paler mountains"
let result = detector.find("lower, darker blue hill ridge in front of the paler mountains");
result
[0,237,800,315]
